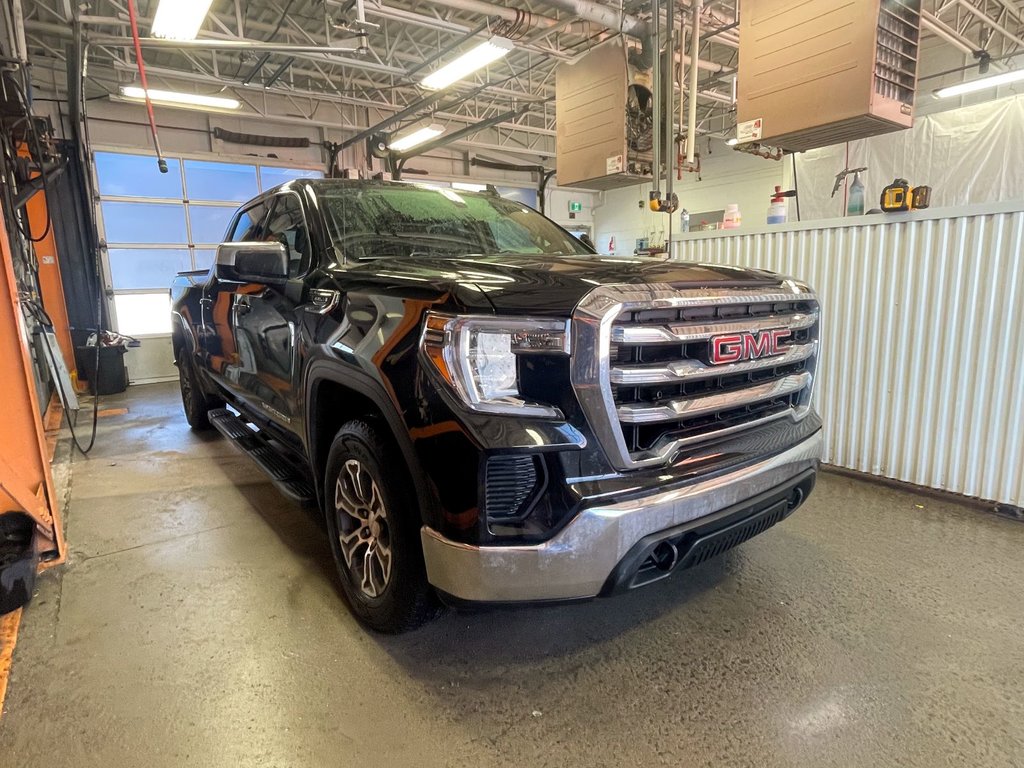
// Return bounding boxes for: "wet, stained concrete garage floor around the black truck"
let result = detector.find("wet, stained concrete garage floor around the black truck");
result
[0,385,1024,768]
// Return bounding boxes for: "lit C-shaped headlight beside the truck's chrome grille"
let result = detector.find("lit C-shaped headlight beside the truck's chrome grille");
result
[420,312,569,418]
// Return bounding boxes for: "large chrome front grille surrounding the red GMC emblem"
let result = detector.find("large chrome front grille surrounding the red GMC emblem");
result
[573,281,819,469]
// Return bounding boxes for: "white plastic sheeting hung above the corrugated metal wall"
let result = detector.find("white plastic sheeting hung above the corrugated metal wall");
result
[790,96,1024,221]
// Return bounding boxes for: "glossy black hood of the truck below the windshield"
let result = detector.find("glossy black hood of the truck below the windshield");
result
[342,254,780,316]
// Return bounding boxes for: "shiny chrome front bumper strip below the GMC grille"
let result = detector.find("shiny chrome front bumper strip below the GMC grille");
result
[421,430,823,602]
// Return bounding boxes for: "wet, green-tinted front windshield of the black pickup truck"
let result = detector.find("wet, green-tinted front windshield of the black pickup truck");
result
[318,185,591,259]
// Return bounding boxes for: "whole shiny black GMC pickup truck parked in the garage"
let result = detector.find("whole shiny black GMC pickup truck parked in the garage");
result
[171,179,822,632]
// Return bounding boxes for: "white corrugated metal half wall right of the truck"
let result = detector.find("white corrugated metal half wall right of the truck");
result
[674,203,1024,506]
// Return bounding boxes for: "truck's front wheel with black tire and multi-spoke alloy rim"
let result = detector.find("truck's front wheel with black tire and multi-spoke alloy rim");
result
[324,420,439,634]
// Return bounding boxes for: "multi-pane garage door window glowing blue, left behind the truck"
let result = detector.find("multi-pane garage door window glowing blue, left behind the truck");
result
[95,152,324,336]
